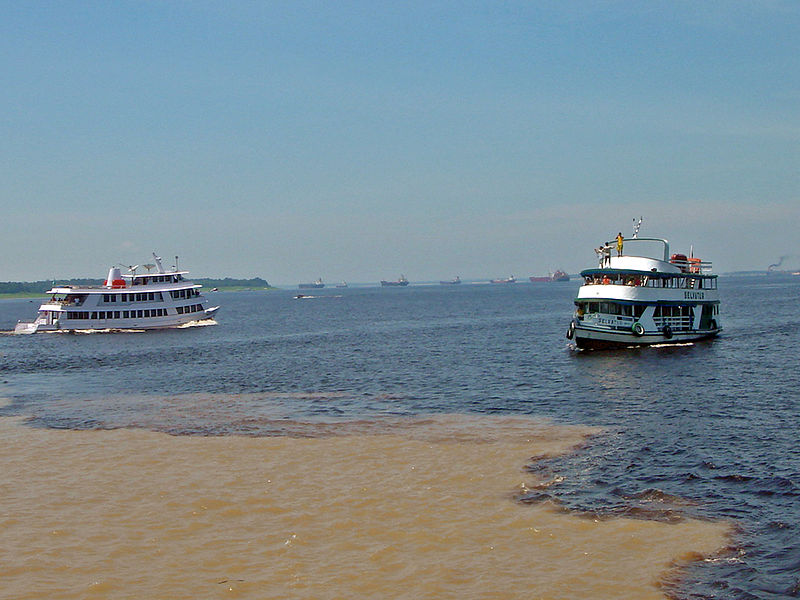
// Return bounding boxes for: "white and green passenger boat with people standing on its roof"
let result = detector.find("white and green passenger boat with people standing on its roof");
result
[567,226,722,349]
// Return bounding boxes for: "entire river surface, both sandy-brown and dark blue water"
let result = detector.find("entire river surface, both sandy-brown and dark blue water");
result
[0,277,800,599]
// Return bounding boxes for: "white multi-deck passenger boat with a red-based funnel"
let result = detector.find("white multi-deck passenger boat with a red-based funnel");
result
[14,254,219,334]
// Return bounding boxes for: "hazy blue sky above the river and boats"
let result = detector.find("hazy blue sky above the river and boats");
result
[0,0,800,285]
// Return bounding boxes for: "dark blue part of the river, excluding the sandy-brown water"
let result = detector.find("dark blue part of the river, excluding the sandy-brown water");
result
[0,277,800,599]
